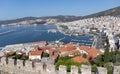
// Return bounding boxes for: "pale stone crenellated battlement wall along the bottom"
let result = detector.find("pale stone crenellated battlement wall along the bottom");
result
[0,57,120,74]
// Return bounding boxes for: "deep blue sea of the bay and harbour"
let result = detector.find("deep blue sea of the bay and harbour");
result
[0,24,93,47]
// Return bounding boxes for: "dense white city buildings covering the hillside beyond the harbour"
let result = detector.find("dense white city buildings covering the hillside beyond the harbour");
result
[59,16,120,49]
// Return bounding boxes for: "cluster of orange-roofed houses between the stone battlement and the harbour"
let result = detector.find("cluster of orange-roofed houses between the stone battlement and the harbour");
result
[0,41,102,64]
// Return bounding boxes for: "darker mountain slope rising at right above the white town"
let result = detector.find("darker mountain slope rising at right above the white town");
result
[84,6,120,18]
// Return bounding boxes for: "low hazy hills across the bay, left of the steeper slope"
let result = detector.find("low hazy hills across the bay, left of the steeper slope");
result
[0,15,81,24]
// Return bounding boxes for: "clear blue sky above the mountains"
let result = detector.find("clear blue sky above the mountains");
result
[0,0,120,20]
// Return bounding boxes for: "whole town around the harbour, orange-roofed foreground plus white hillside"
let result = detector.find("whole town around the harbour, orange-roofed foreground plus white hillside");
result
[0,16,120,72]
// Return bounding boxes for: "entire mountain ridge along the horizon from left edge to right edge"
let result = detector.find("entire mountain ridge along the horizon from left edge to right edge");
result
[0,6,120,24]
